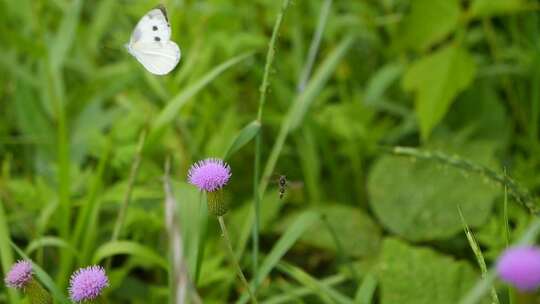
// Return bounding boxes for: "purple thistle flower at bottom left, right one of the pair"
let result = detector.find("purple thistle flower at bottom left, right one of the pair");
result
[69,266,109,303]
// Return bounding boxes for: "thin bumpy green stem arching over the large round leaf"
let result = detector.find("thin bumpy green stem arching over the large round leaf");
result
[381,147,540,216]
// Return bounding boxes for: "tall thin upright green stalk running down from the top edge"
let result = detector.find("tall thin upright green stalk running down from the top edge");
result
[252,0,290,292]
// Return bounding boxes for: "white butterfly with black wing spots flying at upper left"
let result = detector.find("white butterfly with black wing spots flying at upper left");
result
[126,5,181,75]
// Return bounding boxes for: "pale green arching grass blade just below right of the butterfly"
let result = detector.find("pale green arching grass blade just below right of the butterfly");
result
[150,52,253,141]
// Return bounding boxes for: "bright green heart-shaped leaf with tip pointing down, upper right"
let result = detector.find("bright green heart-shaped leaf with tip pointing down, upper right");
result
[403,45,476,140]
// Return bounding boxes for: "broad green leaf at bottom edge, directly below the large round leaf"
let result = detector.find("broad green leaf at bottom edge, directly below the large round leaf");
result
[377,238,479,304]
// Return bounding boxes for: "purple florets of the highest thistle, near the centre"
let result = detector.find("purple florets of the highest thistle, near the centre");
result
[188,158,231,192]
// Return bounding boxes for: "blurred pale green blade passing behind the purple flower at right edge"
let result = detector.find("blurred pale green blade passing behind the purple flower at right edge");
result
[459,217,540,304]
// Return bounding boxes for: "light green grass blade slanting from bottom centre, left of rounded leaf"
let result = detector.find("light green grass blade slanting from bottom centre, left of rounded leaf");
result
[237,211,321,304]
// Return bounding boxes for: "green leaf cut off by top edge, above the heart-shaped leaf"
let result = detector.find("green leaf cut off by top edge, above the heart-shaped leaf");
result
[396,0,461,50]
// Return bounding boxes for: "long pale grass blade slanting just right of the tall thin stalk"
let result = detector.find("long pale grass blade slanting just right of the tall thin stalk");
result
[259,35,354,197]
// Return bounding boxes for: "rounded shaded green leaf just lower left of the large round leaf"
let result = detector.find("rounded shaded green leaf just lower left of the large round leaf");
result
[280,203,381,256]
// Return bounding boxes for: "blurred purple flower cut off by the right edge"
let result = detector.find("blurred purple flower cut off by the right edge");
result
[497,246,540,291]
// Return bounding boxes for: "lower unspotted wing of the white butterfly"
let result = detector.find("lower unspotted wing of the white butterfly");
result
[131,41,181,75]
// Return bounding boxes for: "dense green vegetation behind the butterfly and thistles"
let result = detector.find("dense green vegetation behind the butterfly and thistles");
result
[0,0,540,304]
